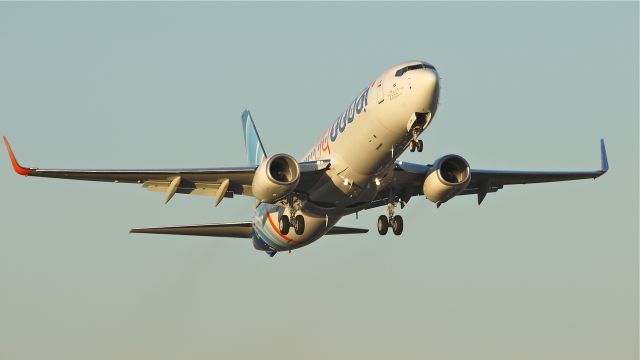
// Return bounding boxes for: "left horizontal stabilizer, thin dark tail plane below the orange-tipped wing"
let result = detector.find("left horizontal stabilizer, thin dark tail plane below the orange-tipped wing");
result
[129,221,253,238]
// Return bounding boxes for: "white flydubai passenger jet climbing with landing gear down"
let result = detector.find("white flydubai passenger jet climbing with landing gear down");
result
[3,61,609,257]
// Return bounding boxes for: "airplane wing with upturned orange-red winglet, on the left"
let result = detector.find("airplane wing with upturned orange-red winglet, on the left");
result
[3,136,324,205]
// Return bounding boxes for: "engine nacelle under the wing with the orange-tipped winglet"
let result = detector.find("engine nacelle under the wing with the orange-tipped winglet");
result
[251,154,300,203]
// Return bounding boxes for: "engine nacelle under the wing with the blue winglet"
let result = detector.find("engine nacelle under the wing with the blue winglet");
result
[422,155,471,204]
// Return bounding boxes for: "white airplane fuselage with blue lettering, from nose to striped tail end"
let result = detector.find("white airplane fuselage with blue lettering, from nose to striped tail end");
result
[254,61,439,251]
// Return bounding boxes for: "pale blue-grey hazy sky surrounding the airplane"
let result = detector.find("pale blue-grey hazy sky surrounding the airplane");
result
[0,3,639,360]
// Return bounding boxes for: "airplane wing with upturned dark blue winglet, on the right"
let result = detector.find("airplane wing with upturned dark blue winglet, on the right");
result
[369,140,609,208]
